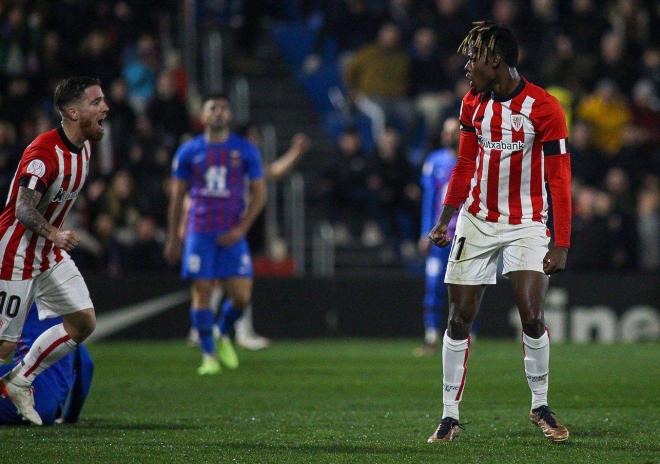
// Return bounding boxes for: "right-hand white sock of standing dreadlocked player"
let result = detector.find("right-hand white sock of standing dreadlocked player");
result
[523,330,550,409]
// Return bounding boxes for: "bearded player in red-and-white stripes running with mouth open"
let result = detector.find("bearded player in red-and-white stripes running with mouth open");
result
[0,77,109,425]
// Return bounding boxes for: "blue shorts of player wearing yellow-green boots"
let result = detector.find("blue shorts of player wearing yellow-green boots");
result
[181,232,252,280]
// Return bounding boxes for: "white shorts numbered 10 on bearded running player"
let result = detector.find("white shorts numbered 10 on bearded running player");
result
[0,259,94,342]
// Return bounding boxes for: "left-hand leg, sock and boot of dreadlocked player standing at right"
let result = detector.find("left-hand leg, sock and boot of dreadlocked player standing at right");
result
[427,284,486,443]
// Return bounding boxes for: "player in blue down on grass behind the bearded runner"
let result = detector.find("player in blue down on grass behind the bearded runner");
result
[0,305,94,425]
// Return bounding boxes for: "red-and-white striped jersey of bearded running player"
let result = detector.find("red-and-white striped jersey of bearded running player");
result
[0,127,90,280]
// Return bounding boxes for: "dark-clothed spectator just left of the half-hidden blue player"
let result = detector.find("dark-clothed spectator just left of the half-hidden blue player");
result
[367,127,421,259]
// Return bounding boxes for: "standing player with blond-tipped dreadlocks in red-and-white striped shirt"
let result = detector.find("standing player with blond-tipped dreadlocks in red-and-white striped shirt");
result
[428,21,571,442]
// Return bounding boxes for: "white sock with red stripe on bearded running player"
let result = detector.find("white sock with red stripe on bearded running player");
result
[8,324,78,386]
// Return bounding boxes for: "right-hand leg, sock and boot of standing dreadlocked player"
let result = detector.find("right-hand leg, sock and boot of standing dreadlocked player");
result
[509,271,569,442]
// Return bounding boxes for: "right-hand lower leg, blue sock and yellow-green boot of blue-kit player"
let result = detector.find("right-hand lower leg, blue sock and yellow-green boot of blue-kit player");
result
[218,277,252,369]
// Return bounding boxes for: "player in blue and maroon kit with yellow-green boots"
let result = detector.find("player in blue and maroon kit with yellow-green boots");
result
[165,94,266,375]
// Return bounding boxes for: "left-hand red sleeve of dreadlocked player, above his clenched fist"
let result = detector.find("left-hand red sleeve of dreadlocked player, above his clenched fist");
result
[443,89,479,209]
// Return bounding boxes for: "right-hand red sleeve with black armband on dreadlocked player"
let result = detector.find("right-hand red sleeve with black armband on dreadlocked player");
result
[534,97,572,248]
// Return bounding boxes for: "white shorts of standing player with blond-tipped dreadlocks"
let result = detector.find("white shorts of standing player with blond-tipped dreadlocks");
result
[445,209,550,285]
